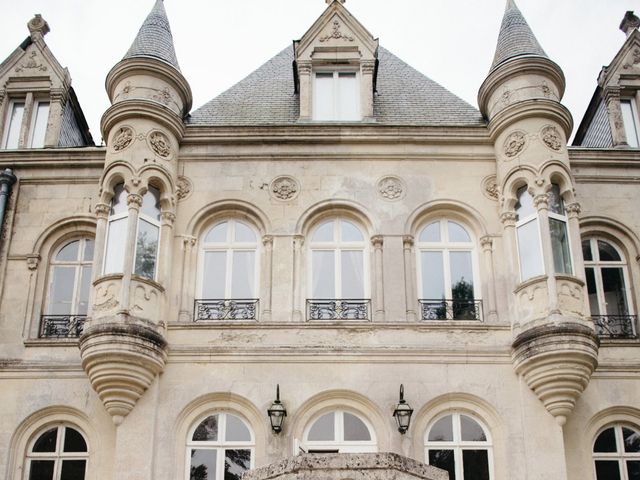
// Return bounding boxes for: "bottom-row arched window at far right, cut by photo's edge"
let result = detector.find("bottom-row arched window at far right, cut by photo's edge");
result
[593,425,640,480]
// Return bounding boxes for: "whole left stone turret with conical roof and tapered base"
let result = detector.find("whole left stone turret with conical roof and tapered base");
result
[80,0,192,424]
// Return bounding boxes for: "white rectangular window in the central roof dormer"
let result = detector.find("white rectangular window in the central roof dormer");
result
[313,71,362,121]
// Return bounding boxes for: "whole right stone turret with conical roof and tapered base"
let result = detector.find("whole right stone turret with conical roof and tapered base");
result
[478,0,598,425]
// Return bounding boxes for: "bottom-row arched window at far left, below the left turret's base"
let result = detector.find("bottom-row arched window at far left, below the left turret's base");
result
[24,425,89,480]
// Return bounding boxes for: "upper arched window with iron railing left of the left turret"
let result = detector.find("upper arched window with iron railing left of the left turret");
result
[39,238,93,337]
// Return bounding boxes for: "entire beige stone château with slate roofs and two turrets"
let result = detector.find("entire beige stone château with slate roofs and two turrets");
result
[0,0,640,480]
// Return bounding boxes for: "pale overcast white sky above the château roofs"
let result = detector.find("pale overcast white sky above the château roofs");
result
[0,0,640,144]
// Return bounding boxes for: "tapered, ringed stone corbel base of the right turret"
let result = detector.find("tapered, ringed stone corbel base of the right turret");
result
[512,322,600,425]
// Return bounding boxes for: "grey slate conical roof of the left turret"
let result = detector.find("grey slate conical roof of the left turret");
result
[123,0,180,70]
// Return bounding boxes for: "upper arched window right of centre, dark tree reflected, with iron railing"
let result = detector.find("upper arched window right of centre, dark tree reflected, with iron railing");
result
[417,219,482,320]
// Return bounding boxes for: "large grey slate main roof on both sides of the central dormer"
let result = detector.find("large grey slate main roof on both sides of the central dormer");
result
[187,47,485,126]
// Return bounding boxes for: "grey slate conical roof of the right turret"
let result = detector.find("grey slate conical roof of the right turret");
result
[491,0,548,70]
